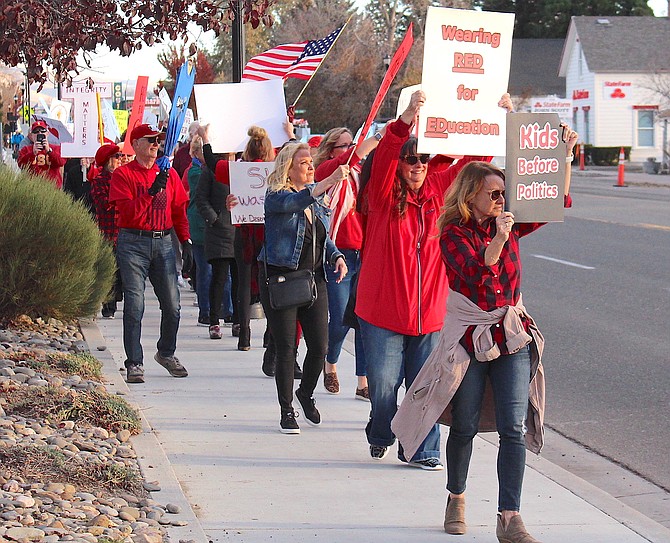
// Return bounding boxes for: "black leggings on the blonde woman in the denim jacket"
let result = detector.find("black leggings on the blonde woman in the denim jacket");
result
[259,269,328,413]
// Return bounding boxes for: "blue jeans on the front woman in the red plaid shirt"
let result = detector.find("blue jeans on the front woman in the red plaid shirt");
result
[447,347,530,511]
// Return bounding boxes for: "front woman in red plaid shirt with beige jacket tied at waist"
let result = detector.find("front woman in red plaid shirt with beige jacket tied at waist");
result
[393,127,577,543]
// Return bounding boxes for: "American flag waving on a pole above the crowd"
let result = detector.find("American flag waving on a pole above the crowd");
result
[242,25,344,81]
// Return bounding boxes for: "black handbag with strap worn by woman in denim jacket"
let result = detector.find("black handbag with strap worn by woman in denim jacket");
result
[263,206,317,310]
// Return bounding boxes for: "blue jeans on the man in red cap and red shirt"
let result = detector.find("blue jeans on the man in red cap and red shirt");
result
[116,229,180,367]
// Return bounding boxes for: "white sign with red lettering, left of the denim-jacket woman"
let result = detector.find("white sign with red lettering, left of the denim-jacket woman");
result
[230,162,275,224]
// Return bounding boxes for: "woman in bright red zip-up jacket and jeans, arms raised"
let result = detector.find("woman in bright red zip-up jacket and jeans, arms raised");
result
[356,91,496,471]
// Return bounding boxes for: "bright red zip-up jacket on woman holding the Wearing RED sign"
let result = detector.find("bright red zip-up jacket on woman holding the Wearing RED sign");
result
[356,120,490,336]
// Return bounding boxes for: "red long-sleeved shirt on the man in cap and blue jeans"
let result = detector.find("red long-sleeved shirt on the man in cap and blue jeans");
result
[109,160,190,242]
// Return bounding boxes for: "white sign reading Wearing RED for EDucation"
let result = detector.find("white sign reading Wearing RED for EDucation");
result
[418,7,514,156]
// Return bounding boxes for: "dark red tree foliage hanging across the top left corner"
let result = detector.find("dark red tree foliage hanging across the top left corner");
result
[0,0,275,89]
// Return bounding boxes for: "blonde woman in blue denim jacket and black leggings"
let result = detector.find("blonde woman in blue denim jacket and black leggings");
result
[258,143,349,434]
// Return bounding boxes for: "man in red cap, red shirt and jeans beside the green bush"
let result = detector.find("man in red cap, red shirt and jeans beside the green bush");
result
[109,124,192,383]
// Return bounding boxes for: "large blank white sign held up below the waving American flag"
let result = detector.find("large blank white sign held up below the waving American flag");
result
[194,78,288,153]
